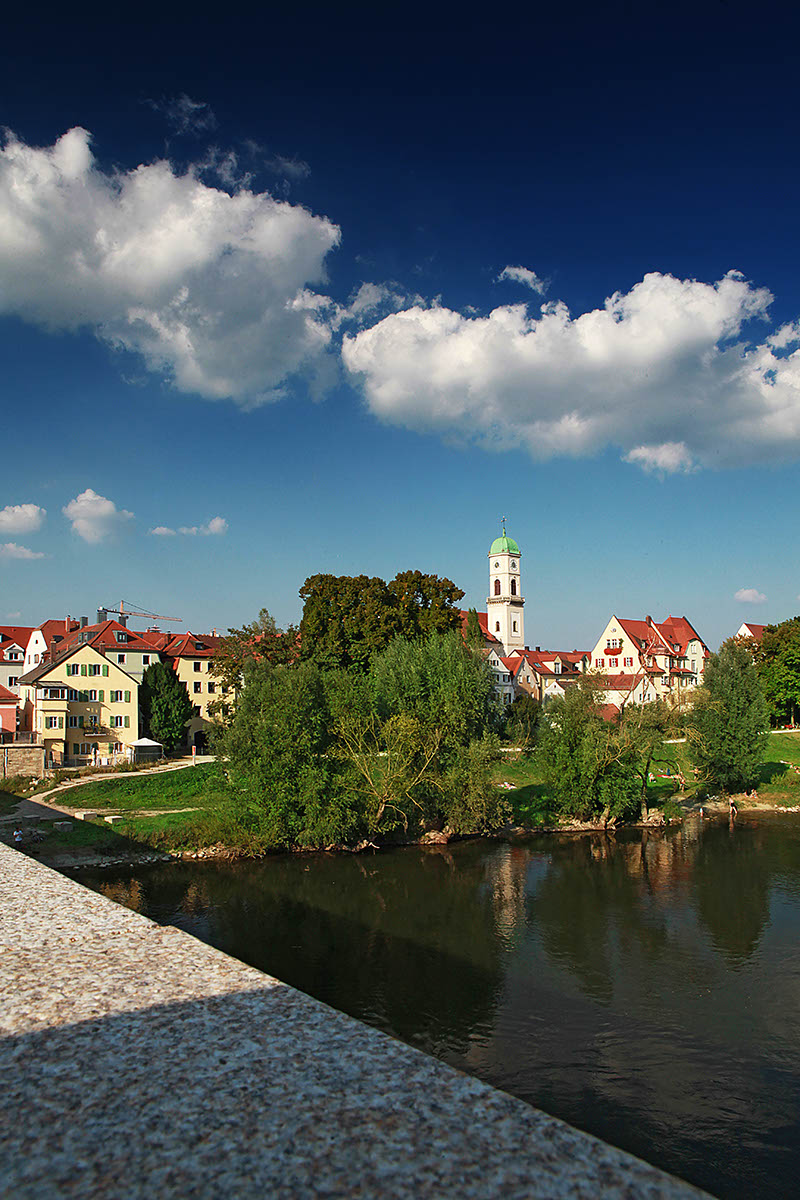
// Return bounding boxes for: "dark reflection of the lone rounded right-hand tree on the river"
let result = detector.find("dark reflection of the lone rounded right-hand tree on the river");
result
[694,823,772,966]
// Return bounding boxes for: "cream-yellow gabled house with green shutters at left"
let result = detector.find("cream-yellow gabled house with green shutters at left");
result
[19,644,139,767]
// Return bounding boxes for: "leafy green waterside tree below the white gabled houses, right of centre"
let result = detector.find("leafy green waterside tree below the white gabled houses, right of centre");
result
[537,677,639,821]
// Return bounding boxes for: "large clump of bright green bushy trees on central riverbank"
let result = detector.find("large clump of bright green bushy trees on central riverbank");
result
[216,631,506,846]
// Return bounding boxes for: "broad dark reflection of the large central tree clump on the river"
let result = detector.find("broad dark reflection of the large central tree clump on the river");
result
[92,844,506,1055]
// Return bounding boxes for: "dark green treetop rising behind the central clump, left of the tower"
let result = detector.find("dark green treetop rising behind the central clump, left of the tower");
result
[300,571,464,671]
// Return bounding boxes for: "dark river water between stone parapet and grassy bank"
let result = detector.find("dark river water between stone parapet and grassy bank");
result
[71,814,800,1198]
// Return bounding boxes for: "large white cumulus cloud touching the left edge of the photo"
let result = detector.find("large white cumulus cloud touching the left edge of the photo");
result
[0,128,339,407]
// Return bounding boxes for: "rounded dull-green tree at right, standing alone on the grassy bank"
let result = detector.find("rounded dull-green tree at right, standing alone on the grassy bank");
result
[686,638,769,793]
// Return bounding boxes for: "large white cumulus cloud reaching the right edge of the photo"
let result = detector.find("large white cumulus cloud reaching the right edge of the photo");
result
[342,271,800,473]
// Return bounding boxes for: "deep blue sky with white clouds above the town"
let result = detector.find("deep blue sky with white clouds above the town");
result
[0,4,800,648]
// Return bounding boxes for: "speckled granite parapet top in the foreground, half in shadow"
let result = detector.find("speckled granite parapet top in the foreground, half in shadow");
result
[0,846,703,1200]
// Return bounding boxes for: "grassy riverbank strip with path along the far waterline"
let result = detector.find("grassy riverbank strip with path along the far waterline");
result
[6,733,800,870]
